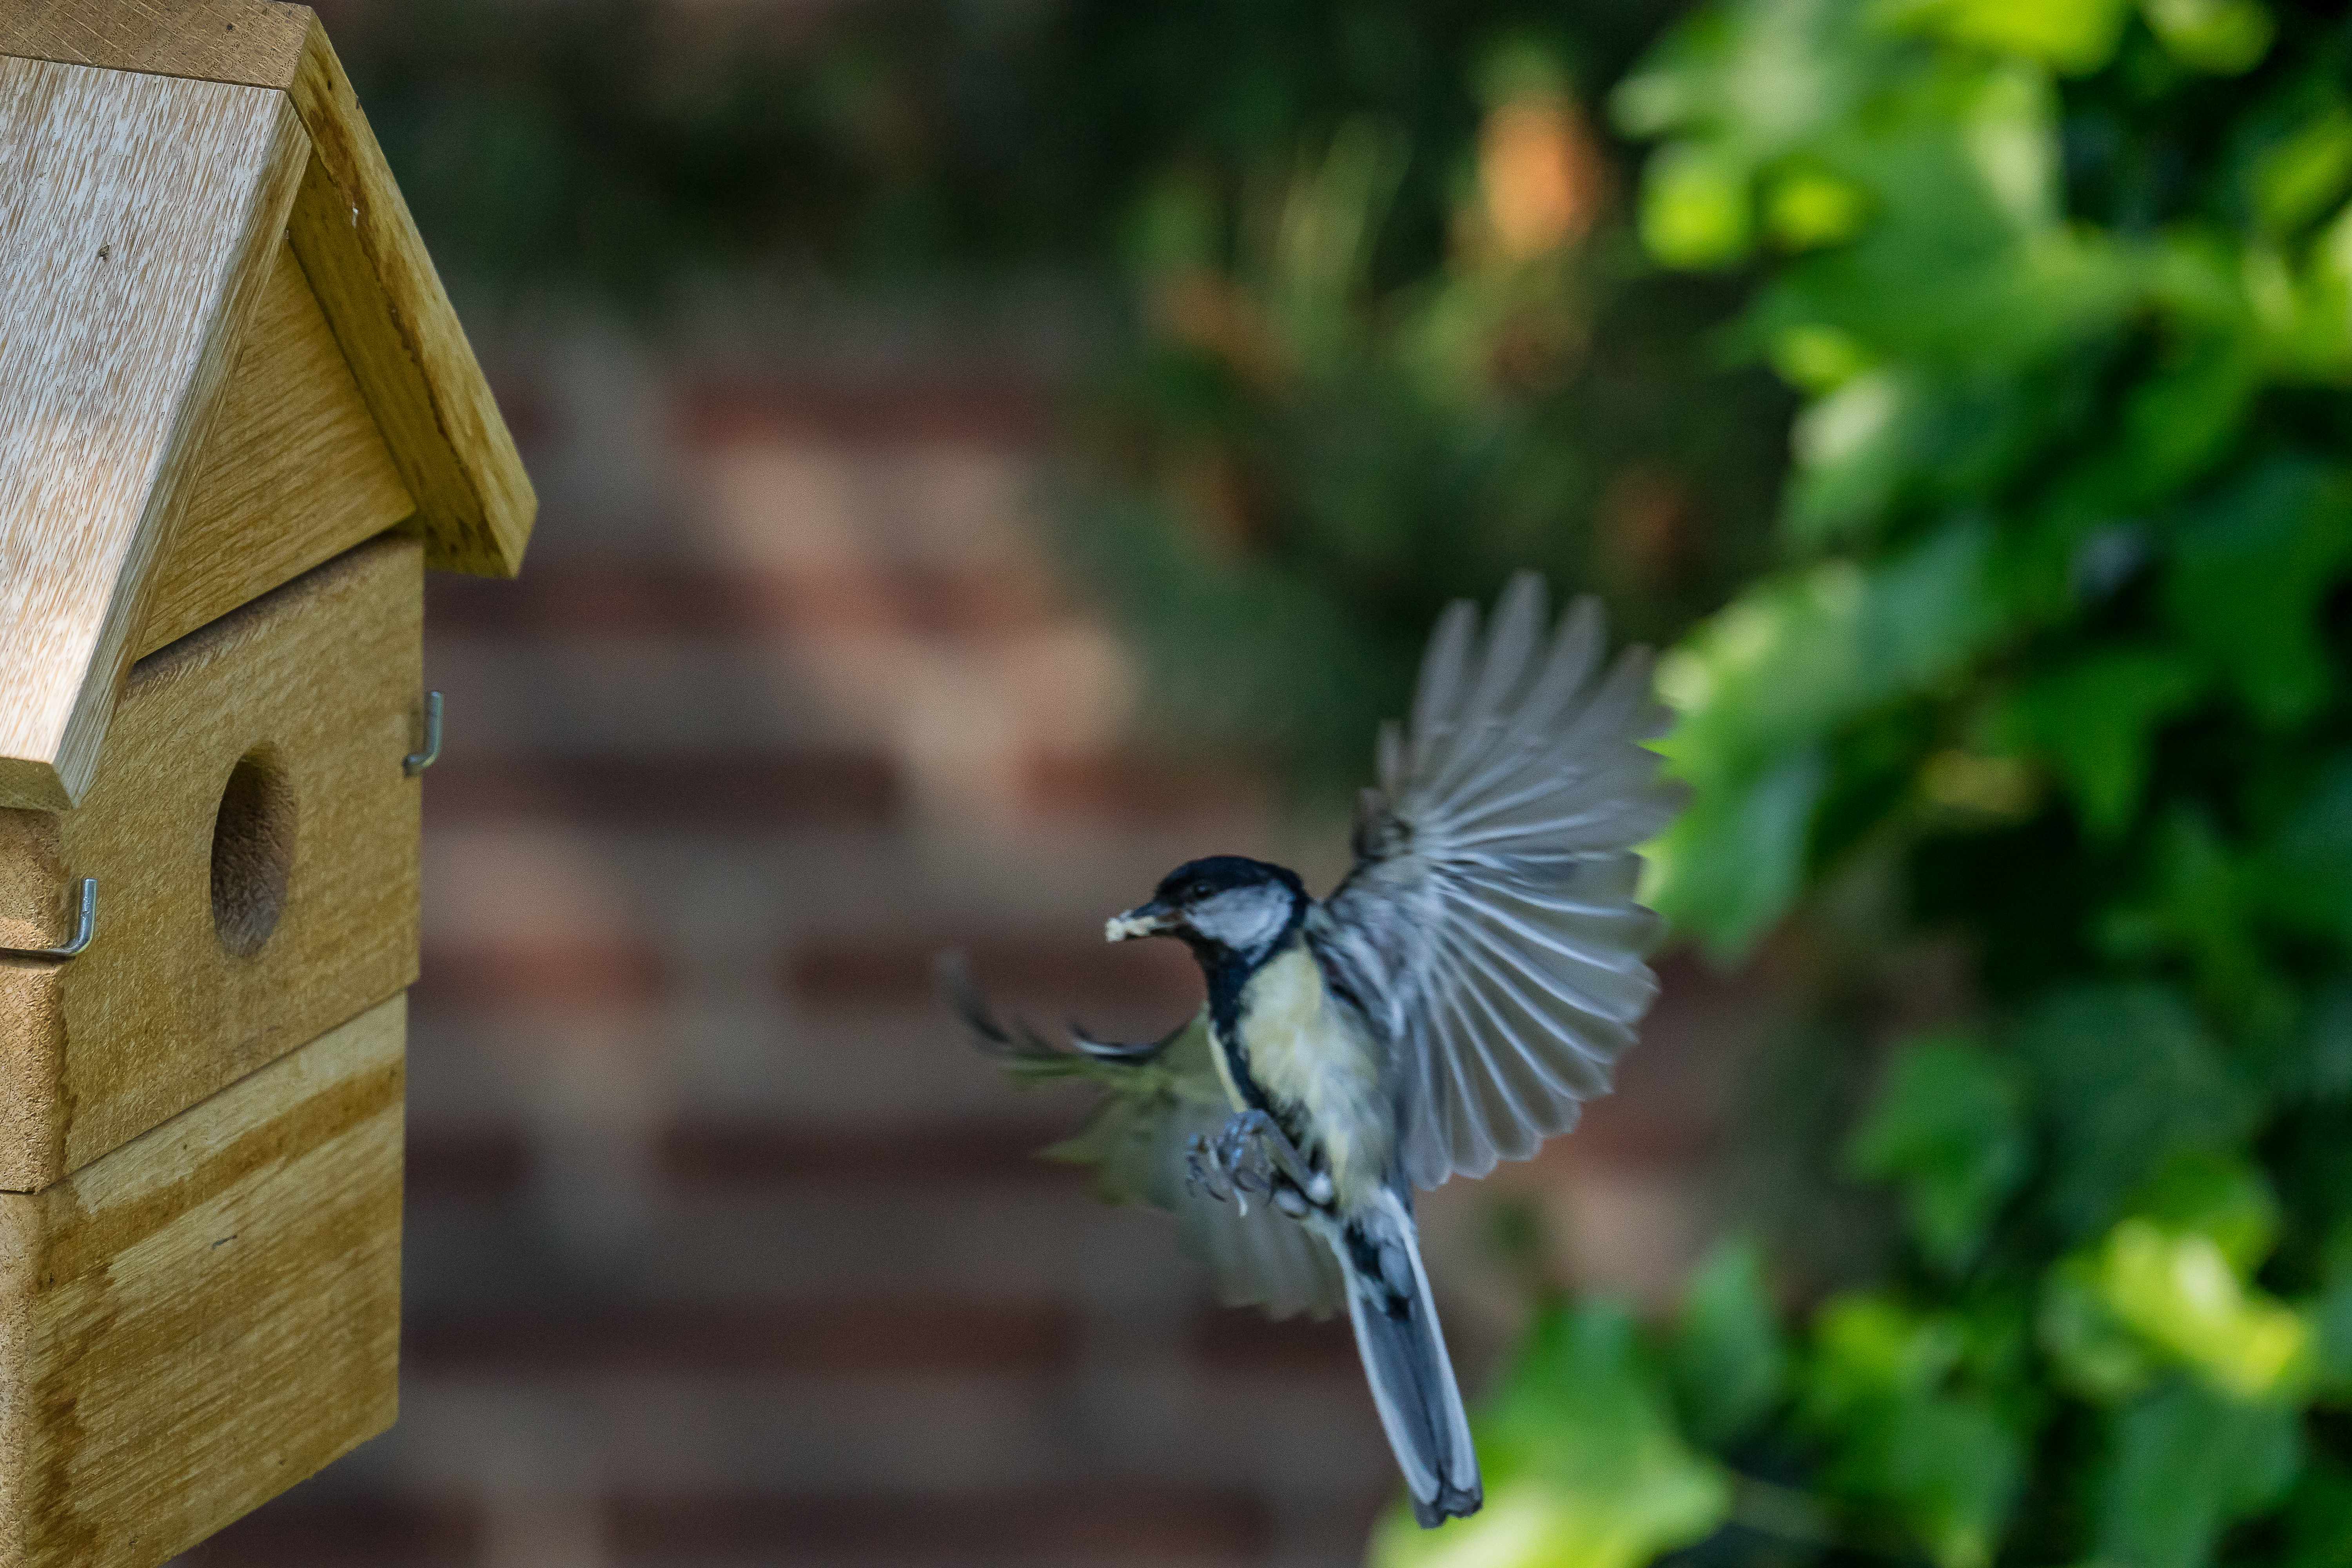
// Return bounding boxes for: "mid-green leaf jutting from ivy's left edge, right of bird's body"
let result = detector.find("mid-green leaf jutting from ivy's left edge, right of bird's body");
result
[1846,1037,2025,1269]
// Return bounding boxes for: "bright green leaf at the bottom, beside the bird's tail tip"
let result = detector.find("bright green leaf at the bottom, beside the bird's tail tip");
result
[1371,1302,1731,1568]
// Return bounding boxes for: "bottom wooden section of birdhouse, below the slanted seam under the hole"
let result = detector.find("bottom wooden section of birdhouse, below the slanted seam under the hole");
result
[0,997,407,1568]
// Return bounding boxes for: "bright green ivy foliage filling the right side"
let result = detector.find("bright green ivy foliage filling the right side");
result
[1376,0,2352,1568]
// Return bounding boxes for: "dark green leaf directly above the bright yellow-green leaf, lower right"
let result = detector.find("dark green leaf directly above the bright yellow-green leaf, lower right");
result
[2013,985,2256,1236]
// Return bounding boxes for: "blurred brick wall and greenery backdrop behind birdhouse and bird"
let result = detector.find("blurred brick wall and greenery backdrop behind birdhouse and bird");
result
[188,0,2352,1568]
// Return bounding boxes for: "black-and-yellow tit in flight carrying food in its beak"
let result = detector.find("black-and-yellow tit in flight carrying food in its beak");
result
[943,573,1679,1528]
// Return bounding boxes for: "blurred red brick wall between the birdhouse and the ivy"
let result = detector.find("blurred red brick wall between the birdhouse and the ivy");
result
[171,341,1769,1568]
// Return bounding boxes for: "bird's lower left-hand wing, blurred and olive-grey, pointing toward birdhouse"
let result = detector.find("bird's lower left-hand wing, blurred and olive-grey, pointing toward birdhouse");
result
[941,959,1345,1319]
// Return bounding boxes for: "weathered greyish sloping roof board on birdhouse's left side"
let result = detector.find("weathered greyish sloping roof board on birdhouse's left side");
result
[0,59,308,809]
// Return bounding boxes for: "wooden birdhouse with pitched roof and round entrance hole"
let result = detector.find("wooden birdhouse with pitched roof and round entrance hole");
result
[0,0,536,1568]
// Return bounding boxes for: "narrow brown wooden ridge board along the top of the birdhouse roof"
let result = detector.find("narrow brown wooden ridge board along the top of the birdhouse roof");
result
[0,0,310,89]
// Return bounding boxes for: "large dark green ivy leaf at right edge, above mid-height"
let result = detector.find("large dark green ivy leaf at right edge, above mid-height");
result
[2164,458,2352,724]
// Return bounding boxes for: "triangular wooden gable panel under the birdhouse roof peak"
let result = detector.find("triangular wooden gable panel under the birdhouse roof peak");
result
[134,242,416,656]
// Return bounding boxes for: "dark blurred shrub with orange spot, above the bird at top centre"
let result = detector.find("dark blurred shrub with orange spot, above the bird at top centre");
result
[1063,20,1783,792]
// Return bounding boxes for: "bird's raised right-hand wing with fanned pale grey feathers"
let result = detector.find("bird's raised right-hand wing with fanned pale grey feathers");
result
[1308,573,1679,1187]
